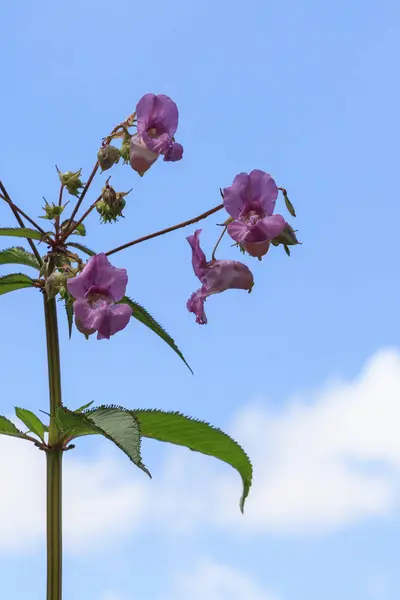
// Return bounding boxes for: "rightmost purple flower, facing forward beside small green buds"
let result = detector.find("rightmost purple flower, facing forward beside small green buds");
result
[224,169,286,257]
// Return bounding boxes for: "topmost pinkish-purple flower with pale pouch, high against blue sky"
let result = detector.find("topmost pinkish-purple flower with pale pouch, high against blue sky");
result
[130,94,183,175]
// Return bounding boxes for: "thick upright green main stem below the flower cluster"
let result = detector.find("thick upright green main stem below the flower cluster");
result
[43,293,63,600]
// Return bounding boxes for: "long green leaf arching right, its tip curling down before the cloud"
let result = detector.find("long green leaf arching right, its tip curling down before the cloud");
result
[132,410,253,512]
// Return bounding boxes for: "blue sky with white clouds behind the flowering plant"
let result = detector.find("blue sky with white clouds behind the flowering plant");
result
[0,0,400,600]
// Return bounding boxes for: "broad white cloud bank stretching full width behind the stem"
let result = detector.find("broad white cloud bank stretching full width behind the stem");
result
[0,351,400,553]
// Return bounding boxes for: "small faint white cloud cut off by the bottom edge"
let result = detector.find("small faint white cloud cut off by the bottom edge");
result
[160,560,276,600]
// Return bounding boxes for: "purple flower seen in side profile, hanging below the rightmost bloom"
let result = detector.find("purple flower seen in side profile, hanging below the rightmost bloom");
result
[186,229,254,325]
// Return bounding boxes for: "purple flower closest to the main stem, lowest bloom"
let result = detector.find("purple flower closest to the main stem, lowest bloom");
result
[67,253,133,340]
